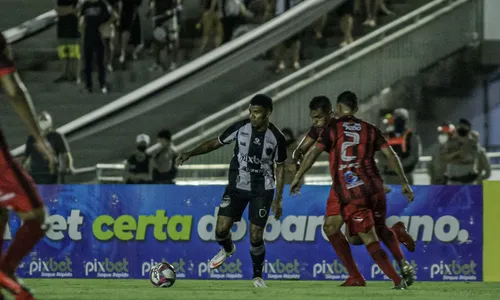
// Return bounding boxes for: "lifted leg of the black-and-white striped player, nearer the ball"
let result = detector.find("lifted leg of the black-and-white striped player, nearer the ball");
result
[210,189,248,269]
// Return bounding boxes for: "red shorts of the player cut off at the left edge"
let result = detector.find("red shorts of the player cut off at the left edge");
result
[0,145,43,212]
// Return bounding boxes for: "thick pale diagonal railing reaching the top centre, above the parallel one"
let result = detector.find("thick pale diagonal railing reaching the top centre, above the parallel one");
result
[11,0,348,156]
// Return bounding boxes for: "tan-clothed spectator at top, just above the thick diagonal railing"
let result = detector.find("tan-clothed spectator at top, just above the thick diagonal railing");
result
[197,0,223,55]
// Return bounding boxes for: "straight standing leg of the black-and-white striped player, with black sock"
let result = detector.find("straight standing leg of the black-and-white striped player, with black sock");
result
[248,191,274,288]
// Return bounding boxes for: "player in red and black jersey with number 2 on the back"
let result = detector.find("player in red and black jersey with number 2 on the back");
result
[291,92,414,289]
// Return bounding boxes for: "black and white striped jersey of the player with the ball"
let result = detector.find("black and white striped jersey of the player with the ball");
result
[219,119,287,193]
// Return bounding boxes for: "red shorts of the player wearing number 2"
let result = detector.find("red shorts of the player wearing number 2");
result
[342,192,387,236]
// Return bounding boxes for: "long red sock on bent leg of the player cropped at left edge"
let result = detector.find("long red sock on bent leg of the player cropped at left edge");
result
[0,220,44,275]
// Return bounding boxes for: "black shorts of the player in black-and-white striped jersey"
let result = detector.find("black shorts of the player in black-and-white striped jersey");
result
[218,187,274,228]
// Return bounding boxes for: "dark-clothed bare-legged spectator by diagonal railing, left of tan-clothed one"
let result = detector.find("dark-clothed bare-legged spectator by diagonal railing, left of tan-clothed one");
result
[149,0,180,71]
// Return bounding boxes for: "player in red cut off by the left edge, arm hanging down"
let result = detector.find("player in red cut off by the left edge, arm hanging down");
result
[0,33,55,300]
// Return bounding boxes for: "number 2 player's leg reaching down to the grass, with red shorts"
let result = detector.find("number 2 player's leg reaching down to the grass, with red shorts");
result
[343,199,407,289]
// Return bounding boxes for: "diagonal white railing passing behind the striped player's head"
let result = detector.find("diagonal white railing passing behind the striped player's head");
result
[159,0,464,155]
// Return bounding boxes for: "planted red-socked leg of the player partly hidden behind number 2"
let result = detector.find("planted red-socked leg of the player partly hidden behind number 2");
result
[323,189,366,286]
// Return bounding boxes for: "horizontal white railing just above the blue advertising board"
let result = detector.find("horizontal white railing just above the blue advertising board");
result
[95,152,500,184]
